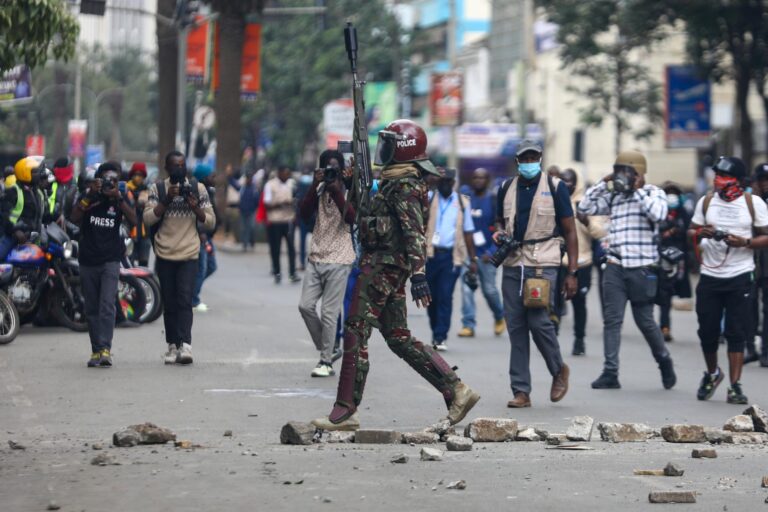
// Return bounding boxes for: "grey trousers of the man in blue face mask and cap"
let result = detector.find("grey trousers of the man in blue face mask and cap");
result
[501,267,563,394]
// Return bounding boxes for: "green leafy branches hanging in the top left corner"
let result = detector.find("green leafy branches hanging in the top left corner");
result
[0,0,80,72]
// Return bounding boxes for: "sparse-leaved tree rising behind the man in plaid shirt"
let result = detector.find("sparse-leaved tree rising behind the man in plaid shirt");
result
[538,0,669,153]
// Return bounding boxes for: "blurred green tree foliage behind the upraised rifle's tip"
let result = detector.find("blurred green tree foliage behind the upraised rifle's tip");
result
[243,0,405,165]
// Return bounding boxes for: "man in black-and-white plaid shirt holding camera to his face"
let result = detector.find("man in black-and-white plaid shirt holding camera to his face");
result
[578,151,677,389]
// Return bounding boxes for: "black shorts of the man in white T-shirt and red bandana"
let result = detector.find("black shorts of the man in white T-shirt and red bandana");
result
[696,272,753,354]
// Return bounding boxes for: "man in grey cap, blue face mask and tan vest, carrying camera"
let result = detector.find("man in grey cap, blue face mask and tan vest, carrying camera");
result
[491,140,578,408]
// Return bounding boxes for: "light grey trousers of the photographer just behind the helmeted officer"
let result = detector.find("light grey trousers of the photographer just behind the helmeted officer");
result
[299,261,352,364]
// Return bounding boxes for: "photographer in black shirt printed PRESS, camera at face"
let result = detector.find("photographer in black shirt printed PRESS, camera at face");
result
[72,162,136,368]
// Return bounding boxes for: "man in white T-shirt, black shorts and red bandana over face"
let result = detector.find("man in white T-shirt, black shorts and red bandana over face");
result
[688,157,768,404]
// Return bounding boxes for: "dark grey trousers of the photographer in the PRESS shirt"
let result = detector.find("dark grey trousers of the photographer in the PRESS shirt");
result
[80,261,120,352]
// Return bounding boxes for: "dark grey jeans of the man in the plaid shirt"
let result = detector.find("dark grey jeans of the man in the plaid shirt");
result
[603,263,669,374]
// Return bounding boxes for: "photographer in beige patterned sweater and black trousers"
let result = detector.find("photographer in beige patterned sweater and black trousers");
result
[144,151,216,364]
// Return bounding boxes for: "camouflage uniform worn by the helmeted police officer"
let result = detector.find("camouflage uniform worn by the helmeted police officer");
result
[330,164,459,423]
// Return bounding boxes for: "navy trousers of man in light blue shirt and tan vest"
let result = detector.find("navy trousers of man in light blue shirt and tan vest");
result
[427,250,461,342]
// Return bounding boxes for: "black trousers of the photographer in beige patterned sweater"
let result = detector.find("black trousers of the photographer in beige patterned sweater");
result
[156,258,198,347]
